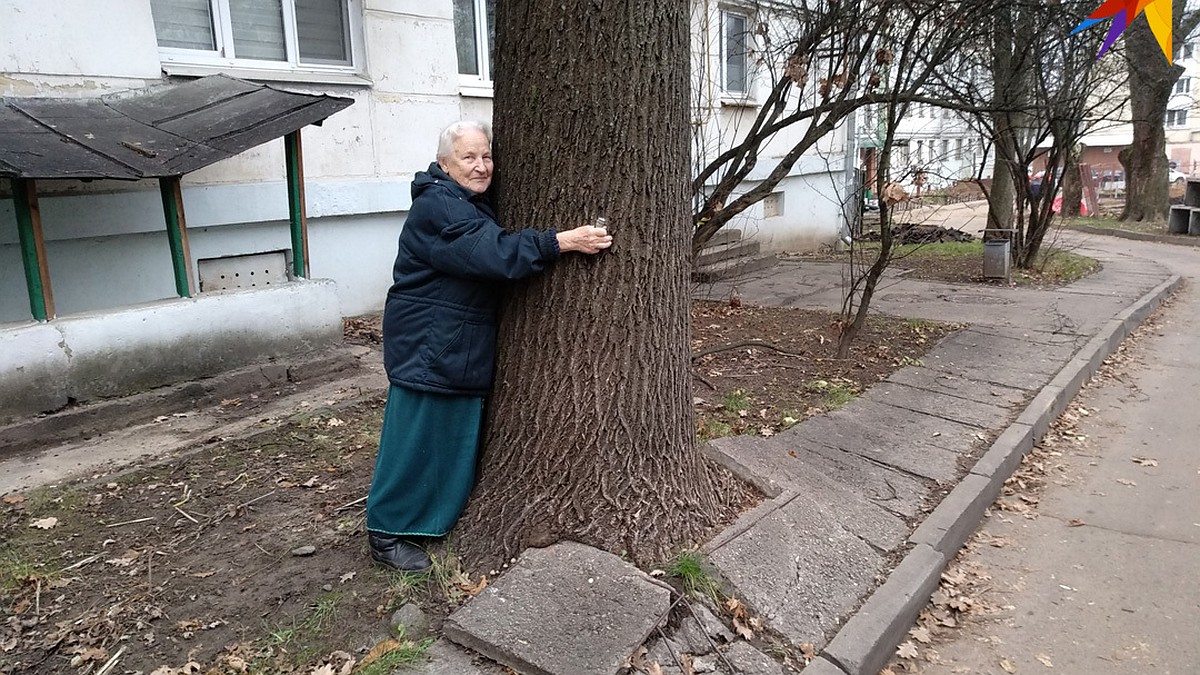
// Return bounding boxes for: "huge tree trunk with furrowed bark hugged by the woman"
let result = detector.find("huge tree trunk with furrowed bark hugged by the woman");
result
[456,0,745,565]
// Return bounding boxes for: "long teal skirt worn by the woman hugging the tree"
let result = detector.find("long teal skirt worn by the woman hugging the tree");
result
[367,386,484,537]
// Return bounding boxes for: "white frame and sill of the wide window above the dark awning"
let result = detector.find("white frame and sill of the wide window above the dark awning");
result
[148,0,371,84]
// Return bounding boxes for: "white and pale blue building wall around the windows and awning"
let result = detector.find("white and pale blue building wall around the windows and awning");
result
[0,0,848,419]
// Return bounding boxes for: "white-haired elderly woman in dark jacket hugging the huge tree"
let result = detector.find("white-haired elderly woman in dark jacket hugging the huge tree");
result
[367,121,612,572]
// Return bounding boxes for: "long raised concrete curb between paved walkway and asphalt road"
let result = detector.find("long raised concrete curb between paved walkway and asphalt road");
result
[818,270,1183,675]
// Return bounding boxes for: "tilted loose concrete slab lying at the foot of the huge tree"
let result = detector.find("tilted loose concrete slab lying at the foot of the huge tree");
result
[443,542,671,675]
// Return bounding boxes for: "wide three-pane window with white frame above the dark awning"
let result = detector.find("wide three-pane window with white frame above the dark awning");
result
[150,0,360,72]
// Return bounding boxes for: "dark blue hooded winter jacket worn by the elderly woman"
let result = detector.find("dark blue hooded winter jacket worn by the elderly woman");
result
[383,162,559,396]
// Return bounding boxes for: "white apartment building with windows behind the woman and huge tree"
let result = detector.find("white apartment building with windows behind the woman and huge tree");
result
[0,0,848,420]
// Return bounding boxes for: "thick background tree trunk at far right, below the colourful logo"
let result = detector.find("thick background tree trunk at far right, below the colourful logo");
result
[1117,11,1183,221]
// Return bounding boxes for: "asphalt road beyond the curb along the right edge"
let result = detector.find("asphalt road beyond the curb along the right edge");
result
[896,238,1200,675]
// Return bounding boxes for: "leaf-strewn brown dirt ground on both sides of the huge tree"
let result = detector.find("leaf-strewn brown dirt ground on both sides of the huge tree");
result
[0,283,953,675]
